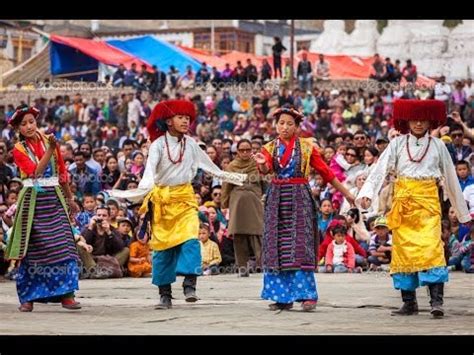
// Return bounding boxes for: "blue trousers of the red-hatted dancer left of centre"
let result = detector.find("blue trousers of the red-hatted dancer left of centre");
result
[152,239,202,286]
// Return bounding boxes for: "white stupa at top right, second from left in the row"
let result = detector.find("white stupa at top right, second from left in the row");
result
[343,20,380,57]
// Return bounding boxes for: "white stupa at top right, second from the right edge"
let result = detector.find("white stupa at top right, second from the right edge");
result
[407,20,449,76]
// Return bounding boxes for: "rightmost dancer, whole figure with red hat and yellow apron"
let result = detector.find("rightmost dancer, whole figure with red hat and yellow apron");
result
[356,100,471,318]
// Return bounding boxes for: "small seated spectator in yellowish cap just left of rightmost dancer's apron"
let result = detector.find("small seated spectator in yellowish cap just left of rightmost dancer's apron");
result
[368,217,392,271]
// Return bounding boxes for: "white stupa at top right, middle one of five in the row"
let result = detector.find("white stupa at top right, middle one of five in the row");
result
[376,20,413,64]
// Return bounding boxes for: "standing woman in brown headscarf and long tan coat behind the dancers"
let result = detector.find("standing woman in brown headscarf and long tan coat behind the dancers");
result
[221,139,263,277]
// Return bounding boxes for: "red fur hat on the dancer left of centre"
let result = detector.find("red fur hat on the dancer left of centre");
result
[146,100,196,142]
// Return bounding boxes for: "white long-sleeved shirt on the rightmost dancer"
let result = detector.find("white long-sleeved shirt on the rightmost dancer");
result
[356,132,471,223]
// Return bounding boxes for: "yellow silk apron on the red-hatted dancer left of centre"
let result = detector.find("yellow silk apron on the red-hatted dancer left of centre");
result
[139,184,199,251]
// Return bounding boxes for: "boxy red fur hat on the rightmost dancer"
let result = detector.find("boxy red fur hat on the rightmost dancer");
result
[393,100,446,134]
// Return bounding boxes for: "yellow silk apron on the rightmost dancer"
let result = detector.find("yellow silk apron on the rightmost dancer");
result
[387,177,446,274]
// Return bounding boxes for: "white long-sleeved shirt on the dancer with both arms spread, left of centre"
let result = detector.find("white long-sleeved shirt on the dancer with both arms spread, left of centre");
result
[111,132,247,202]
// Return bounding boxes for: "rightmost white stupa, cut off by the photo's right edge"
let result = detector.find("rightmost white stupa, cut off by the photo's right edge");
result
[444,20,474,81]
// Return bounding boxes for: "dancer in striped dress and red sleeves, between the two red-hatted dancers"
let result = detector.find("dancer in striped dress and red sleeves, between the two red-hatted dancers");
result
[254,107,354,311]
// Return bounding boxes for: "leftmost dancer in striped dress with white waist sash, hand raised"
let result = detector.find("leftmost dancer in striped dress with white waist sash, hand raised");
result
[6,105,81,312]
